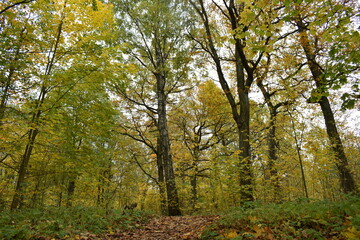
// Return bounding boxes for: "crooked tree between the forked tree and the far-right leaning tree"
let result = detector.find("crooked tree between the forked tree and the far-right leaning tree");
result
[256,37,308,201]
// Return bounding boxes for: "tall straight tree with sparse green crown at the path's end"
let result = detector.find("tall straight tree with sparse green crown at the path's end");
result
[113,0,194,215]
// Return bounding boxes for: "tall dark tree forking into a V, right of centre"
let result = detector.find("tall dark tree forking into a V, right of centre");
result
[190,0,286,202]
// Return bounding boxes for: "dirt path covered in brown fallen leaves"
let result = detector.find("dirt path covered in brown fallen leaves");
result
[95,216,219,240]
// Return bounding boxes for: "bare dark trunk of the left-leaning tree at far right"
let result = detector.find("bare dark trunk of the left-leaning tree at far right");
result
[296,19,356,193]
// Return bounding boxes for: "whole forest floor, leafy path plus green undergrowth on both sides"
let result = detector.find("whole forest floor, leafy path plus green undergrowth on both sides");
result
[0,198,360,240]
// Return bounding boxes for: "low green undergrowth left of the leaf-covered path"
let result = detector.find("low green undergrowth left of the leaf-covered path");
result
[0,207,150,240]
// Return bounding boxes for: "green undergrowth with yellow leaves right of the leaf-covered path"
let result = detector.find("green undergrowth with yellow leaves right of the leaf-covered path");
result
[202,197,360,240]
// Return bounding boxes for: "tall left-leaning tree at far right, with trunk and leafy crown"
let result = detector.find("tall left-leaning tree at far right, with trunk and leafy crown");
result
[285,0,359,193]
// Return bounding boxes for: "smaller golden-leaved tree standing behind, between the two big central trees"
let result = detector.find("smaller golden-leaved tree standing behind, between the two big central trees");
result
[170,81,234,212]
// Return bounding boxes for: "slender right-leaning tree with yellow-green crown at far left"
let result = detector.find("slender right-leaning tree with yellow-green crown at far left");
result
[11,1,115,210]
